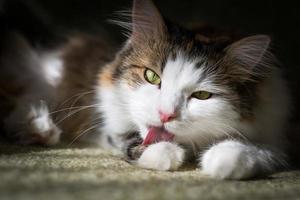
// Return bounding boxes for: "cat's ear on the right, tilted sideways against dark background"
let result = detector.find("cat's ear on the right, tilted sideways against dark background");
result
[226,35,272,79]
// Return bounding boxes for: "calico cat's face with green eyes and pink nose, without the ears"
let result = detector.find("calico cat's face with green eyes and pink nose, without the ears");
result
[117,35,239,145]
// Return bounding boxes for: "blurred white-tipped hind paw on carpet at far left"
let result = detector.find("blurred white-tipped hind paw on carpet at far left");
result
[21,102,61,146]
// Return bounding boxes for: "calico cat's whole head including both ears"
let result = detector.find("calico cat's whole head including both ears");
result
[109,0,270,145]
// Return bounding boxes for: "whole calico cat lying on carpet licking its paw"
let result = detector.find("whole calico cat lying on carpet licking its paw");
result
[0,0,289,179]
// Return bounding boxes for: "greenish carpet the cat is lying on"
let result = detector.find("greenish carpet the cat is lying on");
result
[0,142,300,200]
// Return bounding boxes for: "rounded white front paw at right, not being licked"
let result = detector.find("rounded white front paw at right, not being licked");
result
[201,141,257,180]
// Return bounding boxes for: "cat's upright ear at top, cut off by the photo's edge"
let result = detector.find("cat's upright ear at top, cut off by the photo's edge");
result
[131,0,166,43]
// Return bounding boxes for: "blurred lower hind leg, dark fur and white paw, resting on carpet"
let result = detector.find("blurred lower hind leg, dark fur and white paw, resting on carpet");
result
[5,101,61,145]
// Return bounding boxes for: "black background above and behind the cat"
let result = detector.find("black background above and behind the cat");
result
[0,0,300,122]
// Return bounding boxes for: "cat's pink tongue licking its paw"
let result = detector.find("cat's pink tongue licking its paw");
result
[143,127,174,145]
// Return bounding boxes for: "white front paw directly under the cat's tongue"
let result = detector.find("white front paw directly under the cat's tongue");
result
[137,142,184,171]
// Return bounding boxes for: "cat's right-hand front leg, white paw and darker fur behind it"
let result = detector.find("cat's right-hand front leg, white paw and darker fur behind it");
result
[200,140,285,180]
